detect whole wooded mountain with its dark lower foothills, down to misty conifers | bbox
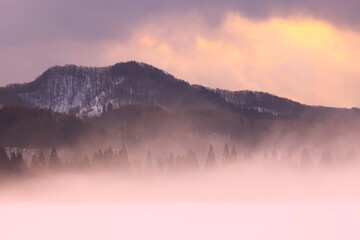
[0,61,360,148]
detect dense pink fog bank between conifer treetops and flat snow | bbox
[0,159,360,203]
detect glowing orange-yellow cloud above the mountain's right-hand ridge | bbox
[104,14,360,107]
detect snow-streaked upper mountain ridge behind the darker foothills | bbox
[0,61,357,119]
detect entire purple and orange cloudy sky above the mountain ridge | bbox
[0,0,360,107]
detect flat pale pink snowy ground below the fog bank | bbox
[0,203,360,240]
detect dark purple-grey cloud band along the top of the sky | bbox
[0,0,360,45]
